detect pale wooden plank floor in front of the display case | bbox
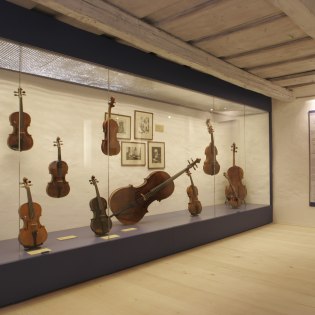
[0,224,315,315]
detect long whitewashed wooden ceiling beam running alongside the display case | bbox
[29,0,294,101]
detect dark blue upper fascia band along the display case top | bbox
[0,1,271,112]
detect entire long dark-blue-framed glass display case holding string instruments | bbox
[0,2,272,306]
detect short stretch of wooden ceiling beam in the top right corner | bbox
[268,0,315,39]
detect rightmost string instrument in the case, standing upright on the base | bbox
[223,143,247,209]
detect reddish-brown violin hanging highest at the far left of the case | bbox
[7,87,33,151]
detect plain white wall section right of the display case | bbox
[272,98,315,227]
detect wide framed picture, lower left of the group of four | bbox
[121,141,146,166]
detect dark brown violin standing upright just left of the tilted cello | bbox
[89,176,112,236]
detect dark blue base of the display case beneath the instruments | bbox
[0,205,272,306]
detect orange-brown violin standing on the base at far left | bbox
[18,177,47,249]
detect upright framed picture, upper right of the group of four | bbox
[134,110,153,140]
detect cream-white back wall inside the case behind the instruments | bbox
[0,70,270,239]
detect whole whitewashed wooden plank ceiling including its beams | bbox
[8,0,315,101]
